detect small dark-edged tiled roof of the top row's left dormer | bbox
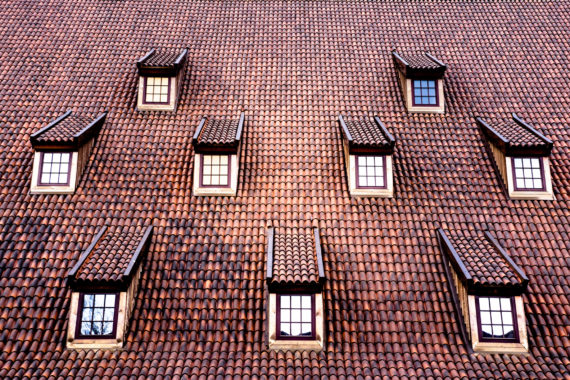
[137,49,188,77]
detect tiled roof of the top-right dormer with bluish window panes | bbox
[392,50,447,79]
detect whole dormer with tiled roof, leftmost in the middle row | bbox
[30,111,107,194]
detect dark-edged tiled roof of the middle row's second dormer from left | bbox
[192,112,245,153]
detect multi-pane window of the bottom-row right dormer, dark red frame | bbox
[477,297,519,342]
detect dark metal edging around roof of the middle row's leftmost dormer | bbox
[30,111,107,150]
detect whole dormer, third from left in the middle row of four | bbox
[339,116,396,197]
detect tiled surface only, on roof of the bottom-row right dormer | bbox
[449,234,522,286]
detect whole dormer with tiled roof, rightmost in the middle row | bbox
[476,114,554,200]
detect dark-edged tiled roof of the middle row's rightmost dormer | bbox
[476,113,553,156]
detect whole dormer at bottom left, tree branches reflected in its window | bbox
[67,226,152,348]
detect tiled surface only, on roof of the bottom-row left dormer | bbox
[75,226,145,282]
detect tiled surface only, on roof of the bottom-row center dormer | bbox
[272,228,319,284]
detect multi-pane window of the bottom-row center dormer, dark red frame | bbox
[277,294,315,339]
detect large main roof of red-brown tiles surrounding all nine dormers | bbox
[0,0,570,379]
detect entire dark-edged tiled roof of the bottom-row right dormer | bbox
[438,229,528,294]
